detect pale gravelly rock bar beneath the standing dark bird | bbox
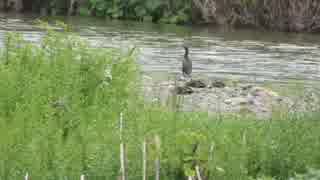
[143,76,320,119]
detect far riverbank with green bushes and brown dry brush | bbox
[0,0,320,32]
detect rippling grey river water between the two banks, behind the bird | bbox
[0,14,320,84]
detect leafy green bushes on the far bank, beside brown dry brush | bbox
[90,0,192,23]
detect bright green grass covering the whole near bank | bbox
[0,25,320,180]
